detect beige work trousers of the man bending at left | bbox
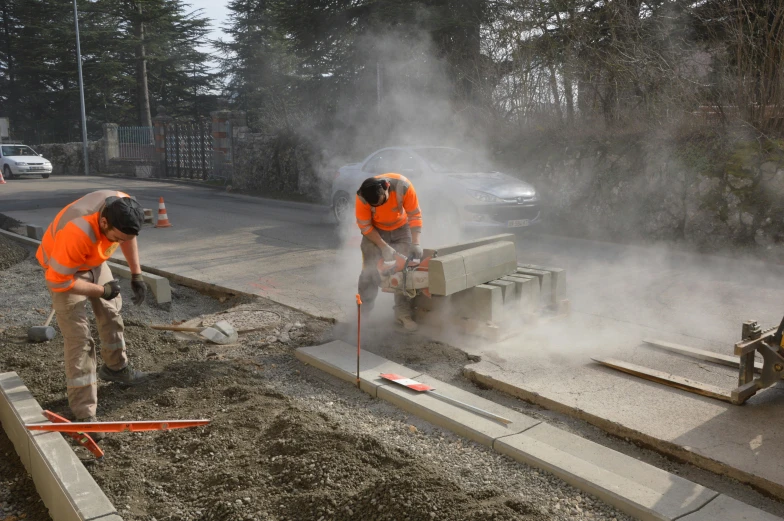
[50,263,128,420]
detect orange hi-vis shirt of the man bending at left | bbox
[35,190,129,293]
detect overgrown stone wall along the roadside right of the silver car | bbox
[508,137,784,251]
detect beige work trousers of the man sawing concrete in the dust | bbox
[357,224,414,318]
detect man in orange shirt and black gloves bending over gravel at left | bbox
[36,190,147,421]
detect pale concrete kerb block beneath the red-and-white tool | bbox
[378,375,541,447]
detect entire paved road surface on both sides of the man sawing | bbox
[0,177,784,504]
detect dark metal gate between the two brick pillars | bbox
[164,121,215,179]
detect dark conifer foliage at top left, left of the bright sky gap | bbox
[0,0,216,143]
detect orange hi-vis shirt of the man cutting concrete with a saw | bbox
[354,174,422,235]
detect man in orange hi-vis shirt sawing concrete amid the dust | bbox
[355,173,422,331]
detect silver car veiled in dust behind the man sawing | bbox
[330,146,541,228]
